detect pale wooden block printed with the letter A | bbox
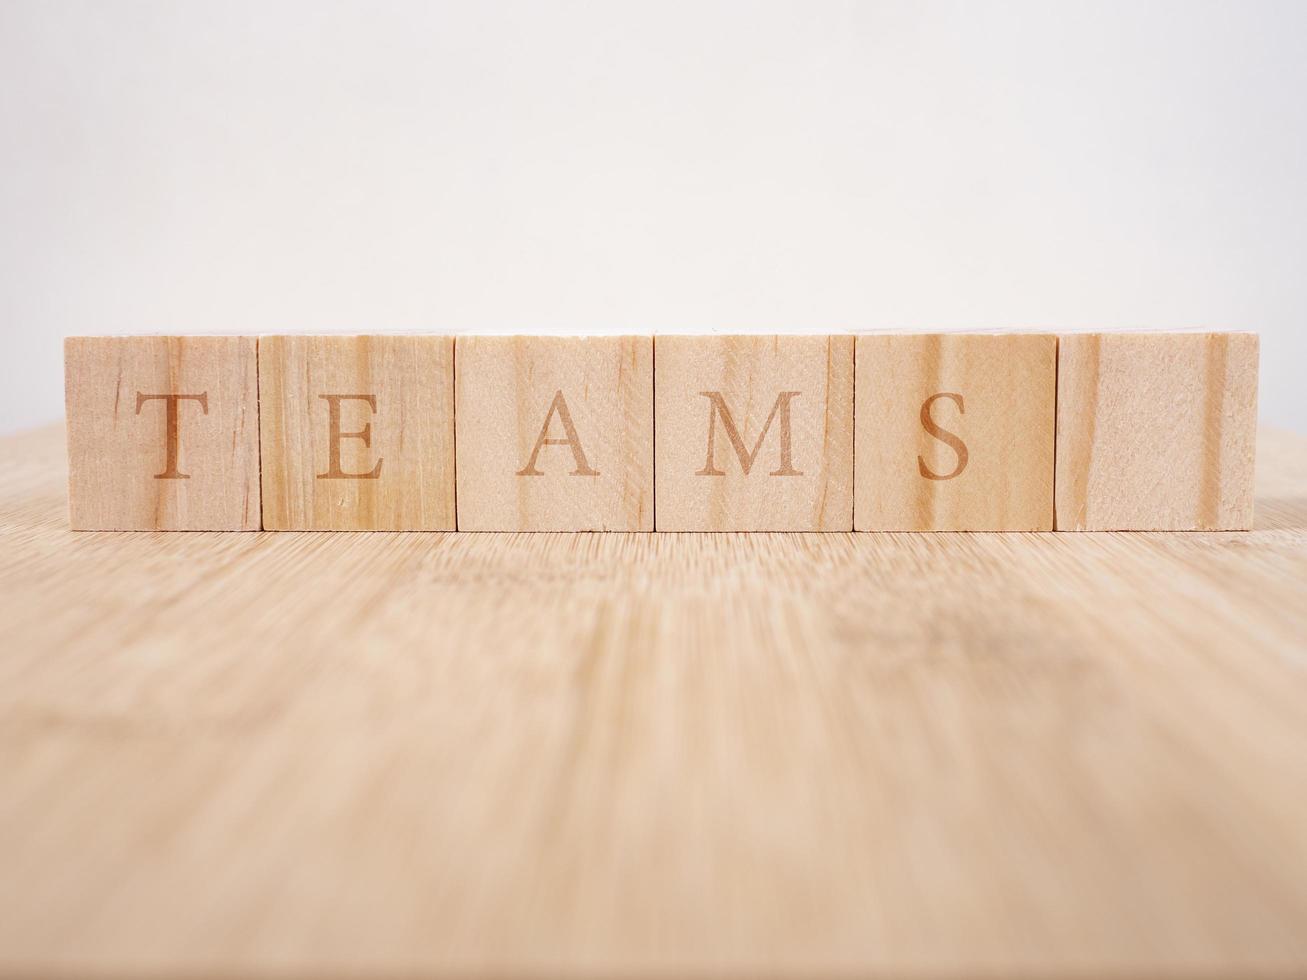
[455,337,654,531]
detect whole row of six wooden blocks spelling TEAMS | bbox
[65,333,1257,531]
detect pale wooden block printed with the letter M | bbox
[654,336,853,531]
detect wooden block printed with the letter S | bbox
[853,333,1057,531]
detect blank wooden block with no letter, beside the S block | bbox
[1056,333,1257,531]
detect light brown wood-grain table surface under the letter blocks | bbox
[0,429,1307,977]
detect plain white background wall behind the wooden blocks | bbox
[0,0,1307,431]
